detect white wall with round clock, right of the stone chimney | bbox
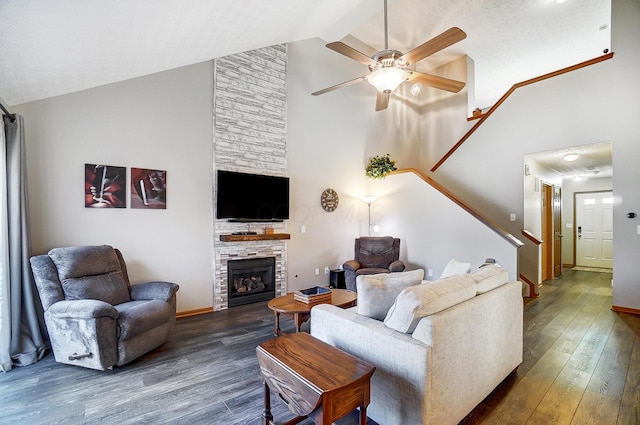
[287,39,417,291]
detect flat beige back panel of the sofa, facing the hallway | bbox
[413,281,523,423]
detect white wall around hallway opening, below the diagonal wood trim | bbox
[433,0,640,309]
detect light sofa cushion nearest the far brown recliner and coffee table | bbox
[356,269,424,320]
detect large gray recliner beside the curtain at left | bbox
[30,245,179,370]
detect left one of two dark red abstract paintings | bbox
[84,164,127,208]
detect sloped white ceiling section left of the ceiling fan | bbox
[0,0,375,105]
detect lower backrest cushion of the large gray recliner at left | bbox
[61,271,131,305]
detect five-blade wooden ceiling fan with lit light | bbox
[311,0,467,111]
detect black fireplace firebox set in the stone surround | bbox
[227,257,276,307]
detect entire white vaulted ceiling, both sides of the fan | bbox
[0,0,611,108]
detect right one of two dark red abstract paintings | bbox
[131,167,167,209]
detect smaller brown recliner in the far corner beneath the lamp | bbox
[342,236,405,291]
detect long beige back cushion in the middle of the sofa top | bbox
[384,275,476,333]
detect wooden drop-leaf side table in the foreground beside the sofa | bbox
[256,332,376,425]
